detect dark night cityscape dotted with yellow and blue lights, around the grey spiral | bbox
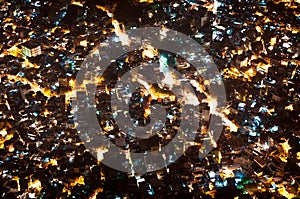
[0,0,300,199]
